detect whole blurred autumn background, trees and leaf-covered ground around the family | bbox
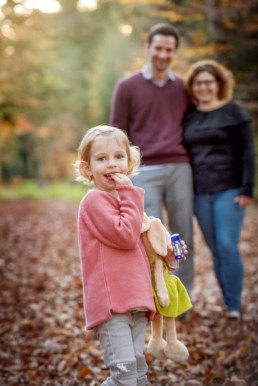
[0,0,258,386]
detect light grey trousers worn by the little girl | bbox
[95,311,148,386]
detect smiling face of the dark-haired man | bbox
[146,35,177,72]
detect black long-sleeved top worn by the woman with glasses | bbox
[184,102,254,196]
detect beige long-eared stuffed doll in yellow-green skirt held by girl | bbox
[142,214,192,362]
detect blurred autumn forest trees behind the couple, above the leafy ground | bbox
[0,0,258,199]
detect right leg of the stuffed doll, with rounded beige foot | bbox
[164,317,189,362]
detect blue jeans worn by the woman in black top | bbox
[194,189,245,311]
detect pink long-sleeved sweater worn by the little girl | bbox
[78,186,156,329]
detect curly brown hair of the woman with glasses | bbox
[184,59,235,103]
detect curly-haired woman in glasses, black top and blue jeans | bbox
[185,60,254,320]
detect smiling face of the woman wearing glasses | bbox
[192,71,219,104]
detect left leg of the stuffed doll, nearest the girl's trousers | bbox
[148,312,166,359]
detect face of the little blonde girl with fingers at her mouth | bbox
[89,135,129,195]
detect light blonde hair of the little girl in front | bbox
[74,125,141,184]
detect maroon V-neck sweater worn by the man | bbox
[110,73,189,165]
